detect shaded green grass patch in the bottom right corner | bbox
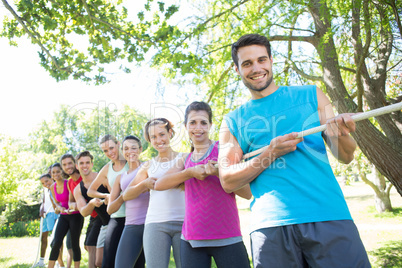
[369,241,402,268]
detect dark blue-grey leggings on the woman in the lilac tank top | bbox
[115,224,144,267]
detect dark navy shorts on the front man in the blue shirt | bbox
[251,220,371,268]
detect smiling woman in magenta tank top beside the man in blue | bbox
[155,102,251,268]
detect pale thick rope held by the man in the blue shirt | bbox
[243,102,402,160]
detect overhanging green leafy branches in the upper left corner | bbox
[1,0,159,84]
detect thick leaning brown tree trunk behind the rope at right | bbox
[308,0,402,196]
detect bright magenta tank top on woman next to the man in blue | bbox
[182,142,241,240]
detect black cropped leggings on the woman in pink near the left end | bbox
[49,213,84,262]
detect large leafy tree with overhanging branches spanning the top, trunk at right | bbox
[2,0,402,195]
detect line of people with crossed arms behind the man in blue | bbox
[37,102,251,268]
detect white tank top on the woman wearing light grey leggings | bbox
[145,153,185,224]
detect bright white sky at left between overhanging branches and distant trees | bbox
[0,2,195,138]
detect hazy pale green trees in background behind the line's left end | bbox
[0,104,156,217]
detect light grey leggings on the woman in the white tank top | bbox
[144,221,183,268]
